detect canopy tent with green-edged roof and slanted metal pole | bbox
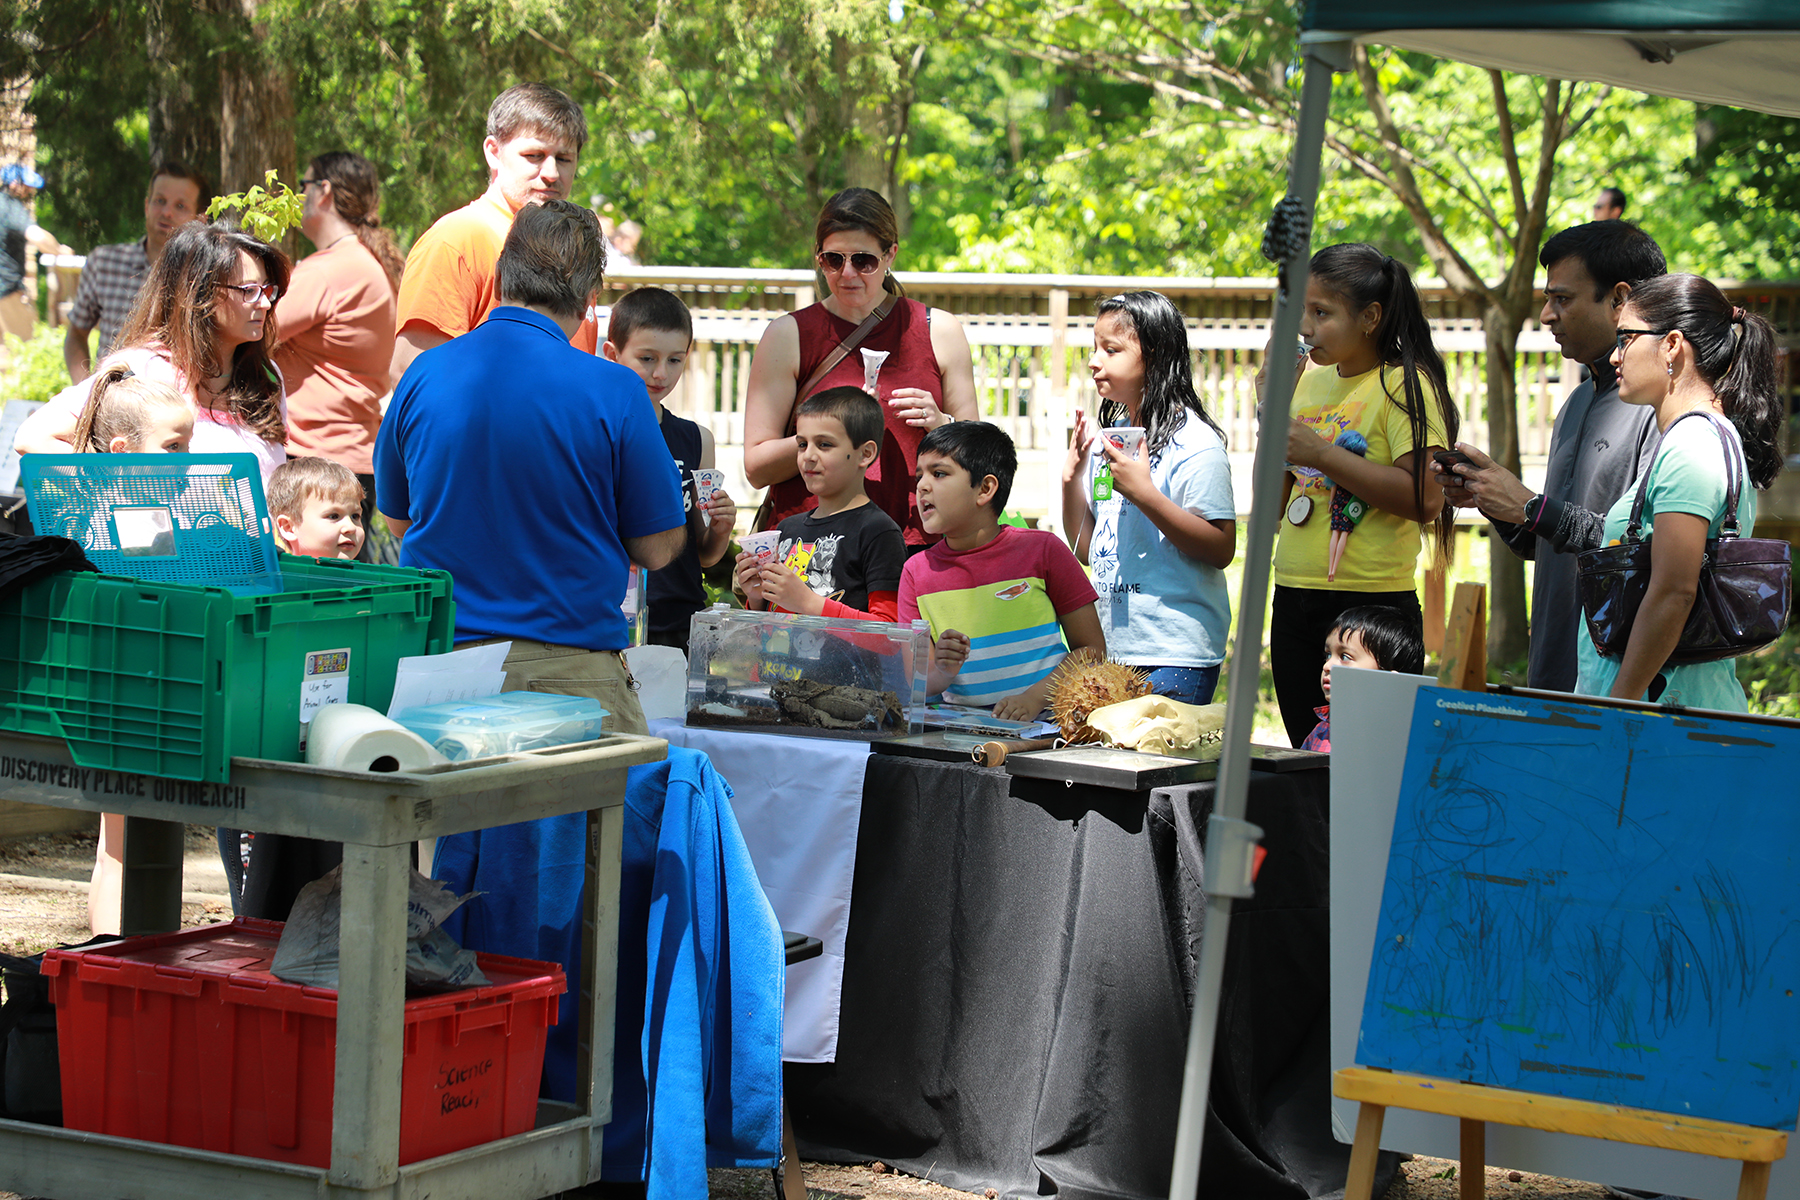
[1168,0,1800,1200]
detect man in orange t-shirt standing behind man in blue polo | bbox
[389,83,596,383]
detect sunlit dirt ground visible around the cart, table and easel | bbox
[0,826,1606,1200]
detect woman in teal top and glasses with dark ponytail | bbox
[1575,275,1782,712]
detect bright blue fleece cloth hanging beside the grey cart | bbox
[432,747,785,1200]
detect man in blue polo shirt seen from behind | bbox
[374,200,688,732]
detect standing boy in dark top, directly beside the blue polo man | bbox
[599,288,738,651]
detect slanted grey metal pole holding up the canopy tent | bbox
[1168,38,1350,1200]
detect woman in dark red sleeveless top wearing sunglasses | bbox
[743,187,979,545]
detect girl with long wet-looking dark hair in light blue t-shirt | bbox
[1062,291,1237,703]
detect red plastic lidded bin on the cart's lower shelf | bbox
[43,918,565,1168]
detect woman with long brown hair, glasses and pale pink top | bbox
[14,221,288,482]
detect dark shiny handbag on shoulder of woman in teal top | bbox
[1575,412,1793,666]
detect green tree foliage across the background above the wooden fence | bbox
[10,0,1800,281]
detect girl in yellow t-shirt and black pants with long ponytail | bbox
[1269,245,1458,745]
